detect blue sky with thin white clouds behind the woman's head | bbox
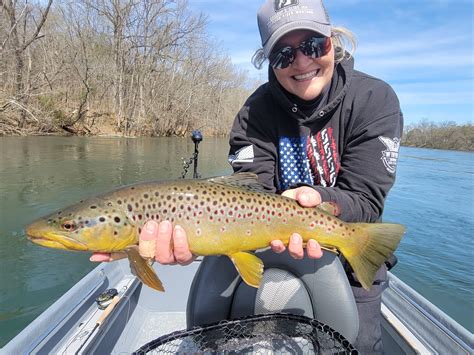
[189,0,474,124]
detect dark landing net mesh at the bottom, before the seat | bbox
[135,314,358,355]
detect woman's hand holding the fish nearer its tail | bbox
[270,186,323,259]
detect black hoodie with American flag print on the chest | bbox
[229,59,403,222]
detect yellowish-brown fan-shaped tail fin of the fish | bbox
[340,223,405,290]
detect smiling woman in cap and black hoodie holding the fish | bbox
[93,0,403,354]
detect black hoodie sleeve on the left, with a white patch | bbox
[229,90,277,192]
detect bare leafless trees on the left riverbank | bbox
[0,0,254,136]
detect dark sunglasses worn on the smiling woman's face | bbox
[268,37,330,69]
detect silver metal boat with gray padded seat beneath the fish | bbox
[0,135,474,354]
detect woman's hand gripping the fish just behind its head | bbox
[90,221,196,265]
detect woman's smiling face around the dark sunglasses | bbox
[273,30,334,101]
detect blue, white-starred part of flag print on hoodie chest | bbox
[279,137,313,191]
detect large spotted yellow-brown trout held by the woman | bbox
[26,173,405,291]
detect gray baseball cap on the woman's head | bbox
[257,0,331,58]
